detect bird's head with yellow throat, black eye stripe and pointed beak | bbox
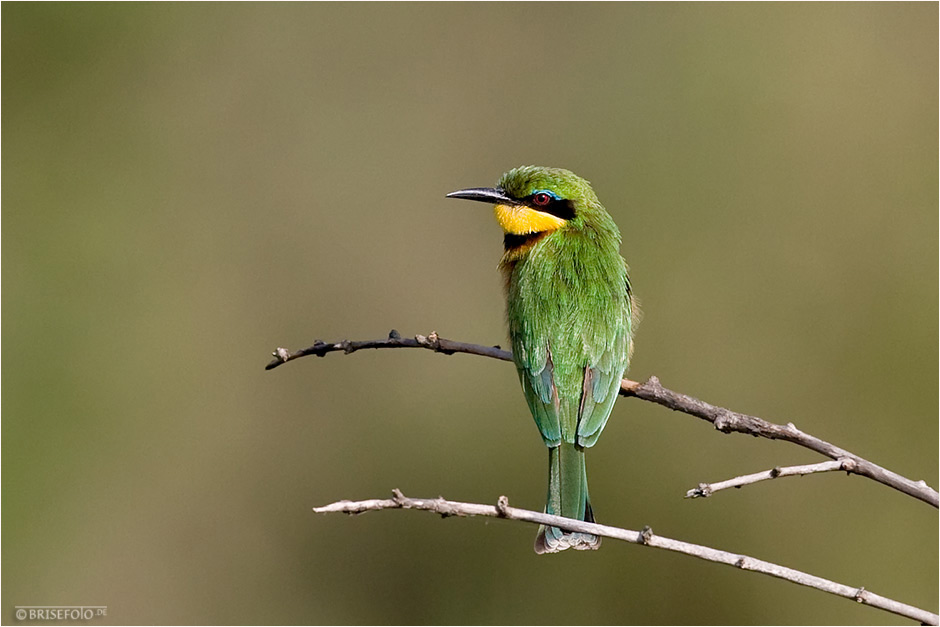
[447,166,606,235]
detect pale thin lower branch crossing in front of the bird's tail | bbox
[313,489,940,625]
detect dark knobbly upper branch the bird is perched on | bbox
[265,330,940,507]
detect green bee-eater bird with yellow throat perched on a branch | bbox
[447,166,636,553]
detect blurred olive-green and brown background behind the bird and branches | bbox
[2,3,938,624]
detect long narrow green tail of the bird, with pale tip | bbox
[535,442,601,553]
